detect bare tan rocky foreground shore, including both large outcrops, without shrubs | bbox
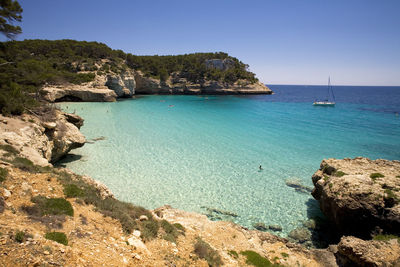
[0,110,400,266]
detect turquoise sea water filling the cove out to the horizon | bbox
[58,86,400,236]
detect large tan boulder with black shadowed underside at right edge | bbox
[312,157,400,238]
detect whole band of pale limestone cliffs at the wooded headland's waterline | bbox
[42,70,273,102]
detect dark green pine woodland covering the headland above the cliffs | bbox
[0,40,257,115]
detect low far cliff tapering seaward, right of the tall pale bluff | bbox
[135,71,272,95]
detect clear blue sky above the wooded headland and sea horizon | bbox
[2,0,400,85]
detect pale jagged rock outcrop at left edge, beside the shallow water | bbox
[0,110,86,166]
